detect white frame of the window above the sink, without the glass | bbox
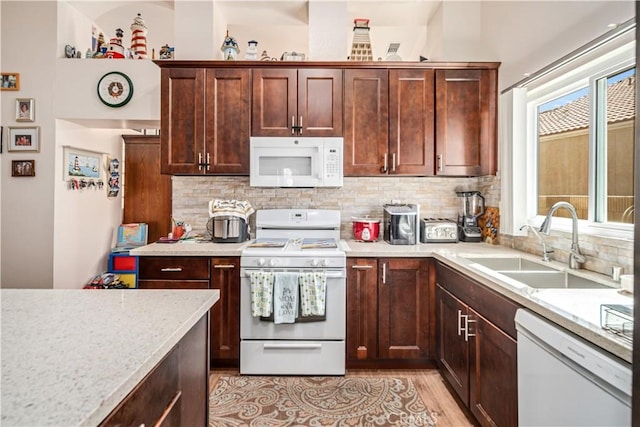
[507,41,637,239]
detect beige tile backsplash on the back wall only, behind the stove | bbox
[173,176,500,239]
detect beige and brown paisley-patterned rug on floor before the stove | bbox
[209,376,435,427]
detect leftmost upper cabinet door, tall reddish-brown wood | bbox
[160,68,204,174]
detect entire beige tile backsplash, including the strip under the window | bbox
[172,176,633,274]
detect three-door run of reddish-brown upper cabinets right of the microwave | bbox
[344,64,497,176]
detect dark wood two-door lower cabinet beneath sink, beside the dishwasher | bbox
[435,263,519,426]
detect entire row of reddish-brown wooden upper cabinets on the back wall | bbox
[156,61,499,176]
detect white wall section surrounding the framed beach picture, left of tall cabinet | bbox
[53,120,123,288]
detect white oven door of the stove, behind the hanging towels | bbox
[240,268,347,340]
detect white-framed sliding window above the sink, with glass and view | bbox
[527,42,636,234]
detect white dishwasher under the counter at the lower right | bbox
[515,309,631,427]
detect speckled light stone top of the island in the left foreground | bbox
[0,289,219,427]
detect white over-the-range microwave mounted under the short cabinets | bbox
[249,136,344,187]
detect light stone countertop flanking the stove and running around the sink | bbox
[131,239,633,363]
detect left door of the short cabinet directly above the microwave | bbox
[251,68,298,136]
